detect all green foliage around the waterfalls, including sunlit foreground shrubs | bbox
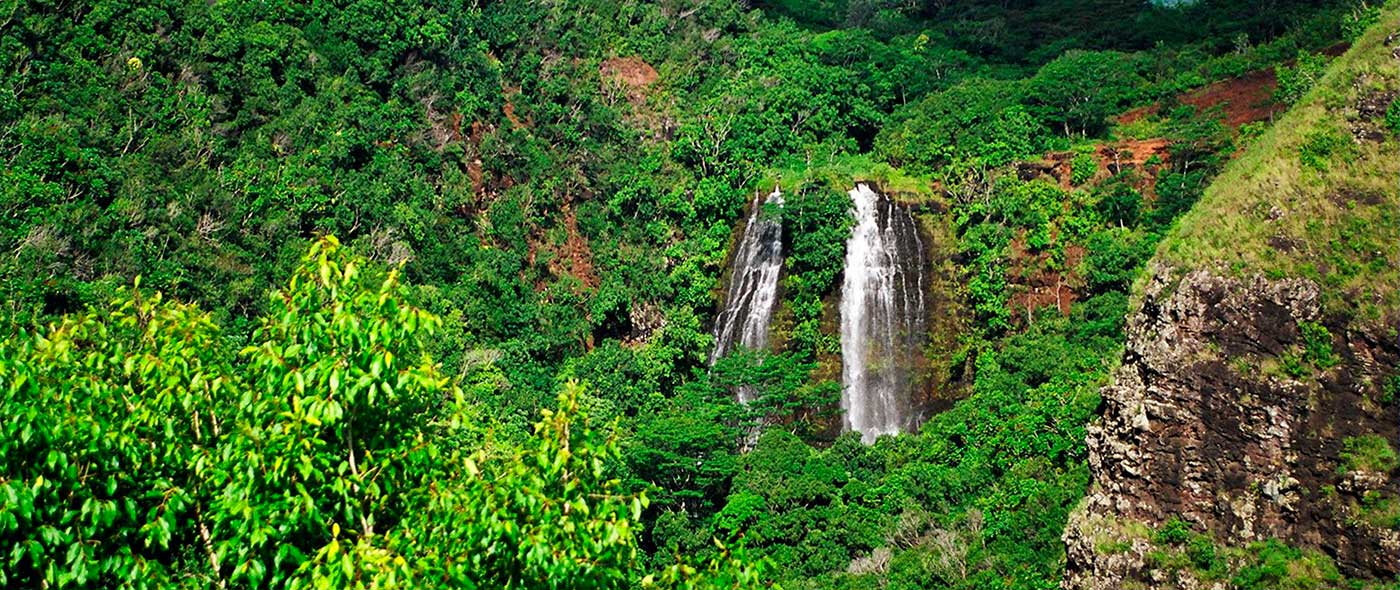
[0,0,1377,589]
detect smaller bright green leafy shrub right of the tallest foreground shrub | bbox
[393,384,647,589]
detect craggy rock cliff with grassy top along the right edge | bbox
[1063,11,1400,590]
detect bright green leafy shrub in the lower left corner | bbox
[0,291,228,587]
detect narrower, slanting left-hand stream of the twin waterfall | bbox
[710,188,783,404]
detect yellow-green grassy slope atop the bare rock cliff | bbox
[1140,1,1400,322]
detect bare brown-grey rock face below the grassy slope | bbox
[1064,266,1400,589]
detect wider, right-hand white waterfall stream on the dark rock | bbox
[841,184,927,443]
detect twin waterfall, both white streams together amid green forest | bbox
[710,184,928,443]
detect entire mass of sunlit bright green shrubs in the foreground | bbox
[0,237,757,589]
